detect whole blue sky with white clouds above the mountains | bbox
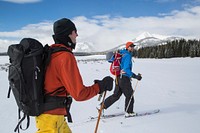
[0,0,200,50]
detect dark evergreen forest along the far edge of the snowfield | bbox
[137,39,200,58]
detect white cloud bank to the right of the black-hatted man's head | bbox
[74,6,200,49]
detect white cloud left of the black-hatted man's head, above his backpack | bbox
[0,21,53,52]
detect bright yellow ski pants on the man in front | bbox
[35,114,72,133]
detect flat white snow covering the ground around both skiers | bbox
[0,56,200,133]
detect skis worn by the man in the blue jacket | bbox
[90,109,160,121]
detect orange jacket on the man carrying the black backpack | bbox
[44,44,99,115]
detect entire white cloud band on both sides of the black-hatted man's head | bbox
[0,6,200,51]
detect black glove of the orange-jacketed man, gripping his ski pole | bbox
[94,76,113,94]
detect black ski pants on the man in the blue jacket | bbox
[104,76,134,113]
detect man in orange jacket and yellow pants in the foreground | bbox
[36,18,113,133]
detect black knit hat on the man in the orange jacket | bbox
[53,18,76,36]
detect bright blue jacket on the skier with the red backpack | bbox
[120,49,135,78]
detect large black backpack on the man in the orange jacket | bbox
[7,38,72,132]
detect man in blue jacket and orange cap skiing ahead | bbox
[103,42,142,117]
